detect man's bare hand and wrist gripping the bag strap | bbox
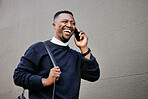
[42,67,61,87]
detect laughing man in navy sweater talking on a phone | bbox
[13,11,100,99]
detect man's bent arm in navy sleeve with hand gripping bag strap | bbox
[13,43,61,90]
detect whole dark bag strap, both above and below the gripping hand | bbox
[43,42,57,99]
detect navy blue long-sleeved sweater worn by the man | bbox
[13,40,100,99]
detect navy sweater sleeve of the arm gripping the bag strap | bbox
[13,46,43,90]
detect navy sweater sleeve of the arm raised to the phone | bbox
[81,54,100,82]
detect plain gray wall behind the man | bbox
[0,0,148,99]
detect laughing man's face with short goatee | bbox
[53,13,75,43]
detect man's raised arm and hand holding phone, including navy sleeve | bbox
[74,31,100,81]
